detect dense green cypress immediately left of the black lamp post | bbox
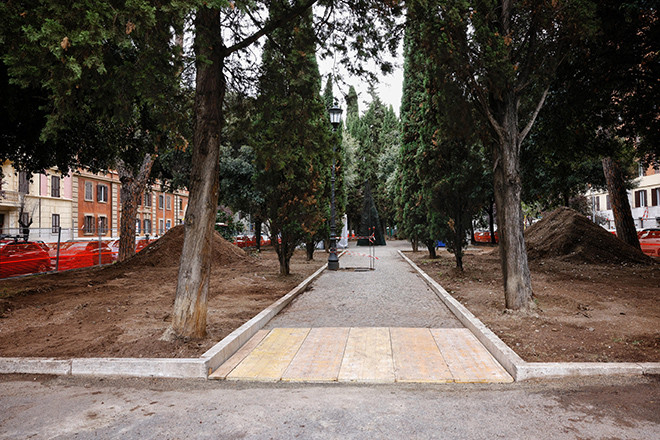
[255,2,332,275]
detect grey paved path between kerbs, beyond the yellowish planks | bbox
[266,241,463,329]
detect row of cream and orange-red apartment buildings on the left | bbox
[0,162,188,242]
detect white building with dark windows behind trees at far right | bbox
[587,163,660,229]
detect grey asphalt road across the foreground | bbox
[0,375,660,440]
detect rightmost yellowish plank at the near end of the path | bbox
[431,328,513,382]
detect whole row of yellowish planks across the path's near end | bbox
[209,327,513,383]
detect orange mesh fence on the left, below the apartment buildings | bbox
[0,227,158,278]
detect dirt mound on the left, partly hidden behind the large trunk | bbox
[123,225,250,268]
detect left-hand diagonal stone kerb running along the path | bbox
[201,255,328,377]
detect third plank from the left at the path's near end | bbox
[282,327,349,382]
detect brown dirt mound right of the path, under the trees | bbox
[525,207,654,264]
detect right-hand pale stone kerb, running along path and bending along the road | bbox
[398,251,660,381]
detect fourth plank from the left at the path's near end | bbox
[338,327,394,383]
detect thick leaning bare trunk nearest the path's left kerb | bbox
[172,7,226,338]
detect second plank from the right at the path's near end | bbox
[390,328,453,383]
